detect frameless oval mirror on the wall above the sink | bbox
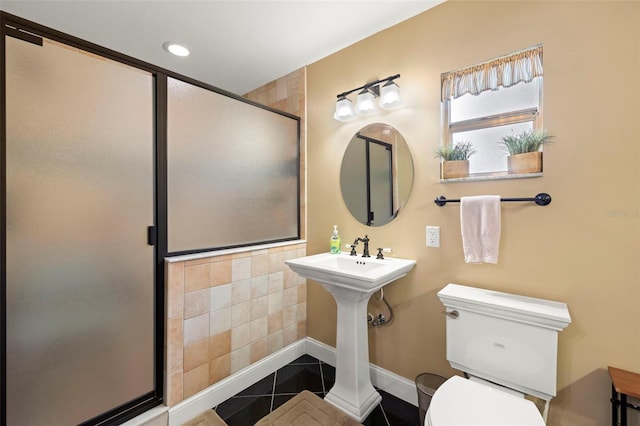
[340,123,413,226]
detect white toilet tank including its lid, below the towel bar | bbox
[438,284,571,400]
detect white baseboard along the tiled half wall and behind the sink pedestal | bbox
[169,337,418,426]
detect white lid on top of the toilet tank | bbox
[438,283,571,331]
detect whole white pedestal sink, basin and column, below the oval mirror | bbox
[285,252,416,422]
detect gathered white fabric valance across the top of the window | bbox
[441,46,542,101]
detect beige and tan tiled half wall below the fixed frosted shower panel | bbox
[165,241,307,407]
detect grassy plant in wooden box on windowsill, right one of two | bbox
[501,129,553,174]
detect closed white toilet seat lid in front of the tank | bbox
[425,376,545,426]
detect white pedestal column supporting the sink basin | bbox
[321,283,382,422]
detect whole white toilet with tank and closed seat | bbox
[425,284,571,426]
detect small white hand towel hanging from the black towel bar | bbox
[460,195,500,263]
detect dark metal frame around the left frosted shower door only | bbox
[0,11,166,425]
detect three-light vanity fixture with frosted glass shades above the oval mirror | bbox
[333,74,402,121]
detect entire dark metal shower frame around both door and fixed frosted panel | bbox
[0,10,301,425]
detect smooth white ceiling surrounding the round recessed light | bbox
[0,0,444,94]
